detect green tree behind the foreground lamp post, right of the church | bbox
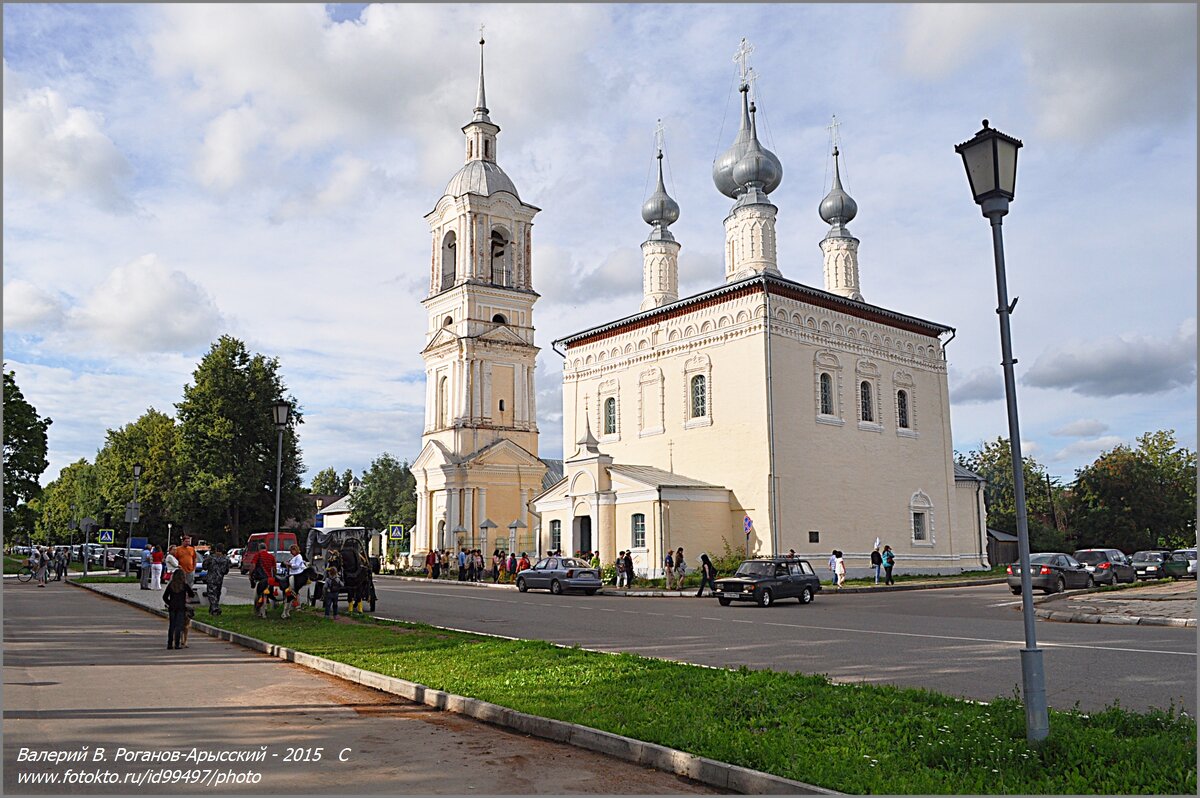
[955,437,1070,552]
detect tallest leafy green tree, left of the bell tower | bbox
[175,336,311,545]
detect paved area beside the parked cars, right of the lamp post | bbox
[1034,580,1196,626]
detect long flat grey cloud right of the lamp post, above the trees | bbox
[1024,319,1196,396]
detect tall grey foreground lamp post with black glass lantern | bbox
[954,119,1050,744]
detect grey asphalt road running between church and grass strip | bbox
[350,578,1196,713]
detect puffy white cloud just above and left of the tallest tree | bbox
[73,253,222,352]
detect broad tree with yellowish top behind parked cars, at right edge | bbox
[1072,430,1196,552]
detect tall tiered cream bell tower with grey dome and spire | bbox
[413,36,545,552]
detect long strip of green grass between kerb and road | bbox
[196,606,1196,794]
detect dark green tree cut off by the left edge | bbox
[4,371,52,538]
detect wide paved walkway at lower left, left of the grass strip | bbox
[4,583,715,794]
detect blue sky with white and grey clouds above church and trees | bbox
[4,4,1196,485]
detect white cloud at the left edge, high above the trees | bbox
[4,61,136,214]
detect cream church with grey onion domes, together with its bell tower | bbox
[413,39,988,576]
